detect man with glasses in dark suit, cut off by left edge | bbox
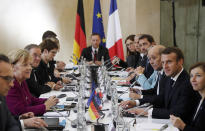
[0,54,47,131]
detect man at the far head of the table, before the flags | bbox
[81,33,111,66]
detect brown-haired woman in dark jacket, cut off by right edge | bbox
[170,62,205,131]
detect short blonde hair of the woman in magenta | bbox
[8,49,31,65]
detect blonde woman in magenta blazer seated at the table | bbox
[6,49,58,116]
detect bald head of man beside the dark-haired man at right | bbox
[148,45,165,71]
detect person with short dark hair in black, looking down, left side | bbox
[36,39,71,89]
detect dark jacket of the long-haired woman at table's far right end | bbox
[118,52,140,68]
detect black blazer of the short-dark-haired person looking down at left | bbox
[36,60,62,85]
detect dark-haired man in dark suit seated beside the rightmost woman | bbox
[120,47,197,123]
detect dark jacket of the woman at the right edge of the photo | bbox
[183,97,205,131]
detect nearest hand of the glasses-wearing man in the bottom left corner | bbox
[23,117,48,128]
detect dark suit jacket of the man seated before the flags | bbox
[81,46,111,66]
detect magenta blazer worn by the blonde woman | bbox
[6,80,46,116]
